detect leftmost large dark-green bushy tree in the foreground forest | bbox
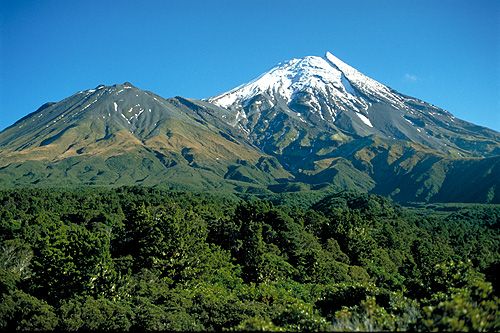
[30,219,113,303]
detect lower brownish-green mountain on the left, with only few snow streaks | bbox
[0,83,291,191]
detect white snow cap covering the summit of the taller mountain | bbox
[206,52,404,118]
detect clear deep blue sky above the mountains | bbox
[0,0,500,131]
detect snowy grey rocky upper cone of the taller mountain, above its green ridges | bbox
[207,53,500,161]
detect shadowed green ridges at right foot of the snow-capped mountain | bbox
[296,135,500,203]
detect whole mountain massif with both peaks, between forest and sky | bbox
[0,53,500,203]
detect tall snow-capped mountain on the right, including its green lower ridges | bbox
[206,53,500,202]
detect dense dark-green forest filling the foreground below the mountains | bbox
[0,187,500,331]
